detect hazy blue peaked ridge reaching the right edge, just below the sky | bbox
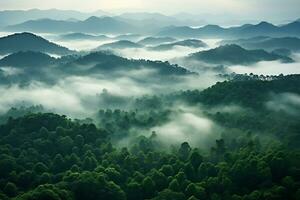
[157,21,300,38]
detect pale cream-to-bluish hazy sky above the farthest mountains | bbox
[0,0,300,21]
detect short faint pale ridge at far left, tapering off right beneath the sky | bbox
[0,9,110,26]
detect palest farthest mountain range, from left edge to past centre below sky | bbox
[0,9,203,31]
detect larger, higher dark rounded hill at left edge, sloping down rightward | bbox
[0,33,73,55]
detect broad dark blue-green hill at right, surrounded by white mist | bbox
[187,45,293,65]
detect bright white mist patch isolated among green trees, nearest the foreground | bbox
[151,105,221,148]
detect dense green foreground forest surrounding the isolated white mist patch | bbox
[0,75,300,200]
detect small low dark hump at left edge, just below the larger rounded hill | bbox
[0,51,56,68]
